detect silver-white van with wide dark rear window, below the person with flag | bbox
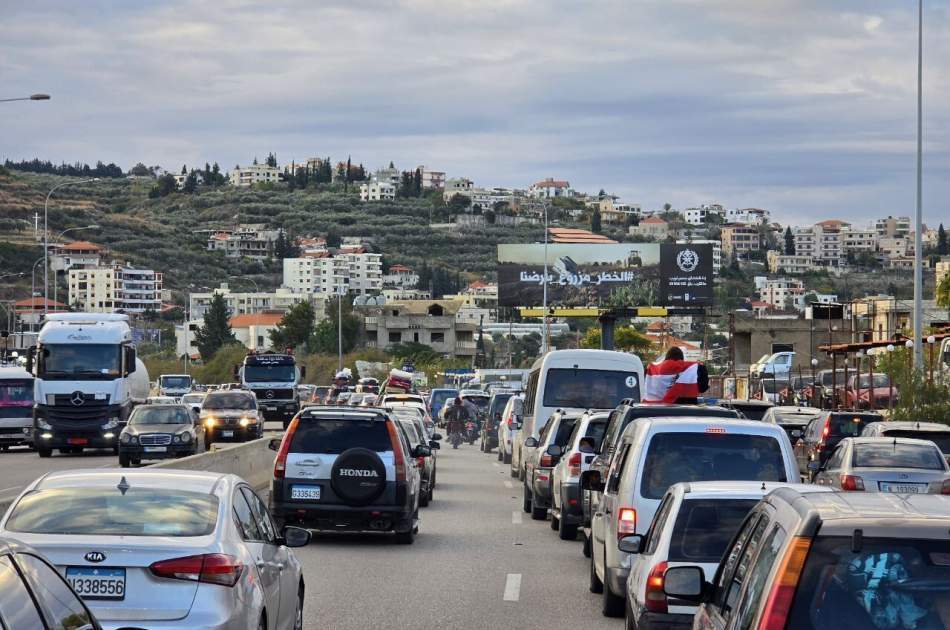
[586,417,799,616]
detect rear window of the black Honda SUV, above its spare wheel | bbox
[290,420,393,455]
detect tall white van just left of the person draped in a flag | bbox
[511,350,643,480]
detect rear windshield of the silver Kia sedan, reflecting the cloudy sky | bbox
[6,488,218,537]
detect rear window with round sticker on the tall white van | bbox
[544,368,640,409]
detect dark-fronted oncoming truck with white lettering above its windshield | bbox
[234,353,306,429]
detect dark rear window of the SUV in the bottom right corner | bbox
[787,536,950,630]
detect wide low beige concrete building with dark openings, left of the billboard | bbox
[361,300,478,359]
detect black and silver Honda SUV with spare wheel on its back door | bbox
[270,407,432,544]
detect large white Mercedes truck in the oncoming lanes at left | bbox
[27,313,149,457]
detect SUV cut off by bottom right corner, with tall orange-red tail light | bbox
[661,487,950,630]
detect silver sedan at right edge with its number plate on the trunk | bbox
[809,437,950,494]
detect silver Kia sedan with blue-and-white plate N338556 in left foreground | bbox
[0,469,310,630]
